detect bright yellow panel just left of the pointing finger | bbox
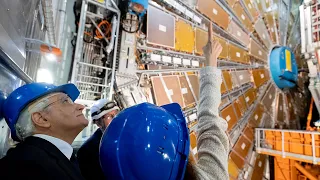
[176,19,194,53]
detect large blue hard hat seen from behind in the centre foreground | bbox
[100,103,190,180]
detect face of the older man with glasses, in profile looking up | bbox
[45,93,88,132]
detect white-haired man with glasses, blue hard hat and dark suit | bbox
[0,83,88,180]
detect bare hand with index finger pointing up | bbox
[203,22,222,67]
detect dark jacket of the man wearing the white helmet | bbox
[77,129,106,180]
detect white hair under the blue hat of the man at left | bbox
[15,93,57,141]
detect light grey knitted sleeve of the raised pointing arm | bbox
[195,67,229,180]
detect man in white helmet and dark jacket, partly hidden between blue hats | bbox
[77,99,120,180]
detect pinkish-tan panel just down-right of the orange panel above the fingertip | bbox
[228,20,250,47]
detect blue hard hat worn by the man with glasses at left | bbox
[1,83,80,141]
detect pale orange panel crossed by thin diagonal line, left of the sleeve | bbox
[151,76,185,107]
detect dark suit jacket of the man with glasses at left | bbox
[0,136,84,180]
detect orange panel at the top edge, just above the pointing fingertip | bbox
[197,0,229,29]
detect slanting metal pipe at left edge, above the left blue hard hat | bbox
[0,47,33,83]
